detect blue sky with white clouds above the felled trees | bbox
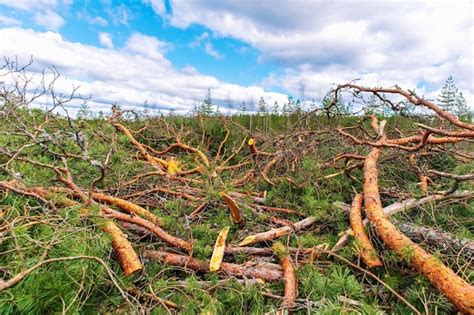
[0,0,474,114]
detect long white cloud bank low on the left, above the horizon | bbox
[0,28,286,114]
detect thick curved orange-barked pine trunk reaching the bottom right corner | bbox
[364,147,474,314]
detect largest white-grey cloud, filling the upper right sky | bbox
[151,0,474,106]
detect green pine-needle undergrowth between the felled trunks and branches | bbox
[0,109,474,314]
